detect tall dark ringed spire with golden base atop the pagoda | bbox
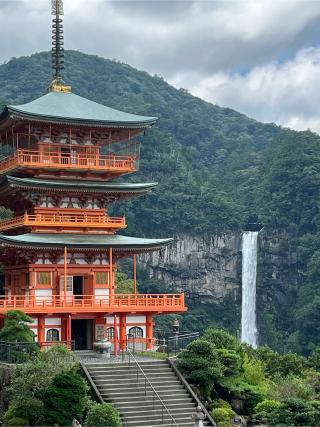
[49,0,71,92]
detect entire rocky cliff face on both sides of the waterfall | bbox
[140,231,302,349]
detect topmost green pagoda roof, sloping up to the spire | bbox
[3,92,157,128]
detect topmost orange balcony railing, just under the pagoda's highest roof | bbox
[0,149,136,173]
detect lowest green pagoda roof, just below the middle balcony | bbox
[0,233,173,252]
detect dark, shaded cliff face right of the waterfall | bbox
[257,231,303,350]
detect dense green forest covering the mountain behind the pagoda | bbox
[0,51,320,354]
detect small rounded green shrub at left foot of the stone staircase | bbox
[85,403,122,427]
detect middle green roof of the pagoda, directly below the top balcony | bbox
[0,175,157,195]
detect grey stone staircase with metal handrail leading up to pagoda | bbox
[85,360,212,427]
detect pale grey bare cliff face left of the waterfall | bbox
[140,234,241,303]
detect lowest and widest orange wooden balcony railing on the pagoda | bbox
[0,293,186,314]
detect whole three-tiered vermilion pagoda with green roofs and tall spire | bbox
[0,0,186,349]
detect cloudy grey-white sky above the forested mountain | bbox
[0,0,320,133]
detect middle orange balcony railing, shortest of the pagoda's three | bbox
[0,214,127,231]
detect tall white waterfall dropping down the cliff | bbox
[241,231,259,347]
